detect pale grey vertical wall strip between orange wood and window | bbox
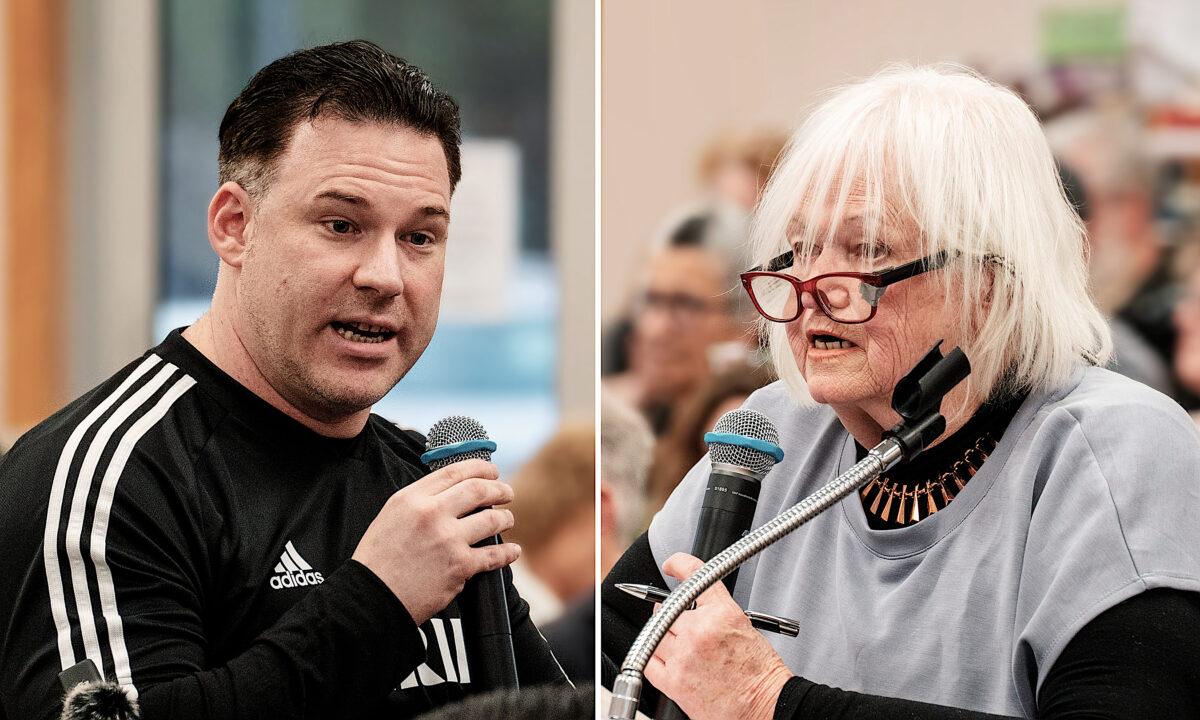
[64,0,157,397]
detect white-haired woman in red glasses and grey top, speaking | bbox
[602,66,1200,719]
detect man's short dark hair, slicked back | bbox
[217,40,462,194]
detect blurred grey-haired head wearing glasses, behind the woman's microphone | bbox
[605,205,755,433]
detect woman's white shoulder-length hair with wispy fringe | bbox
[751,64,1112,402]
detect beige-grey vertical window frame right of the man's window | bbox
[550,0,596,420]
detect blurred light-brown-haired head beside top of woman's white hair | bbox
[696,130,787,212]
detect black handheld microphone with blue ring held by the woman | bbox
[654,409,784,720]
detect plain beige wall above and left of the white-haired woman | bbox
[601,0,1123,322]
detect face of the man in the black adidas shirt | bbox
[236,118,450,419]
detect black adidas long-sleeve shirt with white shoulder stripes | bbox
[0,331,564,720]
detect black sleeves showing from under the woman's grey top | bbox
[609,534,1200,720]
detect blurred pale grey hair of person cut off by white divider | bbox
[600,390,654,545]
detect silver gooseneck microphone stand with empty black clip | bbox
[608,341,971,720]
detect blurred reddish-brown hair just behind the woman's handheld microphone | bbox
[648,364,775,510]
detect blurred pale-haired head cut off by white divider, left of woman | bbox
[600,391,658,577]
